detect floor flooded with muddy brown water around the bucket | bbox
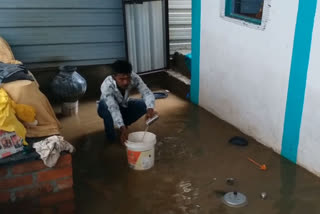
[57,95,320,214]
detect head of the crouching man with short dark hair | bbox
[111,60,132,90]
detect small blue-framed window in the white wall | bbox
[225,0,264,25]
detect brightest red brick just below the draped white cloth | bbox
[38,167,72,182]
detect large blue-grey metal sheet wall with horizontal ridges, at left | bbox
[0,0,125,67]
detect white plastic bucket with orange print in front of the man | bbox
[125,132,157,170]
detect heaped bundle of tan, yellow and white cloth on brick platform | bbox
[0,37,74,167]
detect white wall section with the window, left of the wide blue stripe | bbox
[199,0,300,153]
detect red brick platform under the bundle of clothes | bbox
[0,153,74,213]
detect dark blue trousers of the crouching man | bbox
[98,99,147,141]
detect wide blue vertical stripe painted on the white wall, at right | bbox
[281,0,317,162]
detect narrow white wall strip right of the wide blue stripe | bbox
[298,3,320,176]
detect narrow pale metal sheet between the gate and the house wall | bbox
[169,0,191,54]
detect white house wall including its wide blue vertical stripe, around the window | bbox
[199,0,320,176]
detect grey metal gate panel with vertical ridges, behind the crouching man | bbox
[126,0,166,73]
